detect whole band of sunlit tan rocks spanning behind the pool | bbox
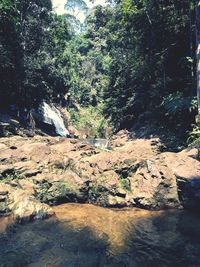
[0,132,200,220]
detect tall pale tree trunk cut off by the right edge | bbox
[196,1,200,121]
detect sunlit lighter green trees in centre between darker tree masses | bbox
[67,7,111,106]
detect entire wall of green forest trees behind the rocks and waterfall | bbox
[0,0,198,146]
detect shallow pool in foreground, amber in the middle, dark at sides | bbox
[0,204,200,267]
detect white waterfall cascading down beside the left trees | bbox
[42,102,69,137]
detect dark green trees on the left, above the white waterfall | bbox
[0,0,69,107]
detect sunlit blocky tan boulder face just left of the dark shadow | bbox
[131,159,180,209]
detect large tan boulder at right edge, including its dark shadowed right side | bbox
[128,149,200,211]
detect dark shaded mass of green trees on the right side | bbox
[101,0,196,135]
